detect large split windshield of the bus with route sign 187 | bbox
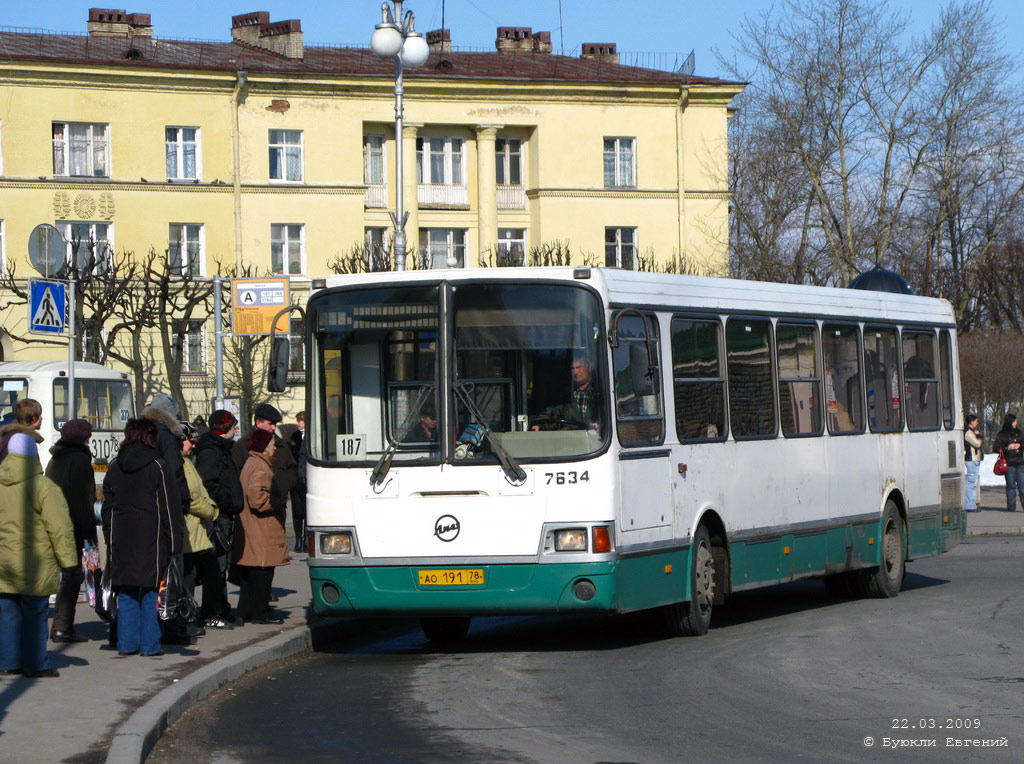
[309,283,608,466]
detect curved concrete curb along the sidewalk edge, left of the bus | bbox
[106,620,386,764]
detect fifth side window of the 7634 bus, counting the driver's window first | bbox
[821,324,864,435]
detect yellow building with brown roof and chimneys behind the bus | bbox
[0,9,742,413]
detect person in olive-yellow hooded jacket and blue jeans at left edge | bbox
[0,432,80,677]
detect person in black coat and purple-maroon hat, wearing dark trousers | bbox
[46,419,96,642]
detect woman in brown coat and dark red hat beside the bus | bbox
[236,430,289,624]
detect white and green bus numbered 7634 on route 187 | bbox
[270,267,966,639]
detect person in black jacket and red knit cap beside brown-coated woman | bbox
[195,409,245,621]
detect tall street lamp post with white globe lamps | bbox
[370,0,430,270]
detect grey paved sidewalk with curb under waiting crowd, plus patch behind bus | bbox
[0,497,1024,764]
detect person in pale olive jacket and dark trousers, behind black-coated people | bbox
[178,422,232,629]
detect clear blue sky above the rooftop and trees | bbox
[9,0,1024,76]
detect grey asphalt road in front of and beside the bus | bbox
[146,537,1024,764]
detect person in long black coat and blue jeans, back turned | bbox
[102,419,184,655]
